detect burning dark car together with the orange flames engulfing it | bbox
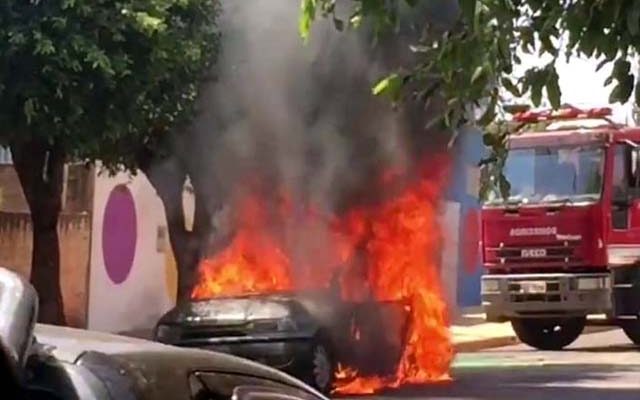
[155,159,453,394]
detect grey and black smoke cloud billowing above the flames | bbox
[176,0,456,276]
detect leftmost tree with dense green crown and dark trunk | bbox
[0,0,218,324]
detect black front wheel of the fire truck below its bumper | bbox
[511,317,587,350]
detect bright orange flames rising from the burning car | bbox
[193,157,453,394]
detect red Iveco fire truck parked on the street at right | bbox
[480,107,640,350]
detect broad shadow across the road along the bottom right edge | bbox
[348,365,640,400]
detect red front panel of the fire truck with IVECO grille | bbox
[482,204,606,274]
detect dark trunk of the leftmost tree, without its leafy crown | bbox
[11,140,66,325]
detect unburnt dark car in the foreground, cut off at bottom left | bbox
[0,268,326,400]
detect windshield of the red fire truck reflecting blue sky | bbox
[487,145,604,204]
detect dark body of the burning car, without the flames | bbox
[154,291,409,393]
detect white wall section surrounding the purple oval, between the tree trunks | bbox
[88,167,175,332]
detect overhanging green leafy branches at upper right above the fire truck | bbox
[300,0,640,195]
